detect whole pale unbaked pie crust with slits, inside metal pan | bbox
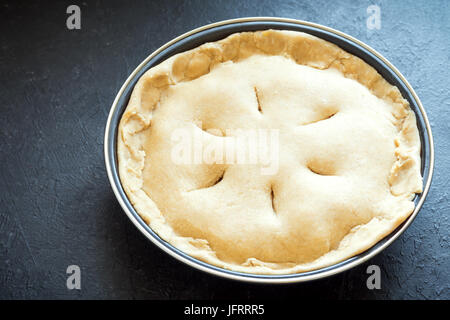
[117,30,422,274]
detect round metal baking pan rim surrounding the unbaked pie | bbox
[104,17,434,283]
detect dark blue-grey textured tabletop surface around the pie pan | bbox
[0,0,450,299]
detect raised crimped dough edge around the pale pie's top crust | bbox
[117,30,422,274]
